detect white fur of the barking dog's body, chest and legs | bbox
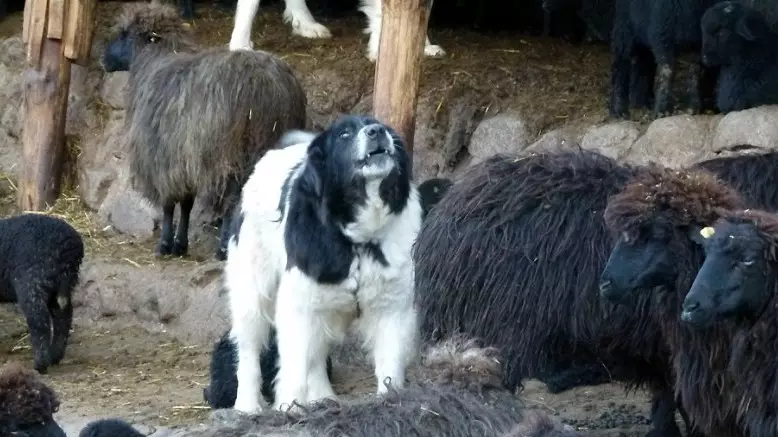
[225,136,421,413]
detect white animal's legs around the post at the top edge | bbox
[230,0,446,62]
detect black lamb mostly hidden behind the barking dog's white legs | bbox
[203,328,332,409]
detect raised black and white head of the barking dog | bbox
[300,115,410,197]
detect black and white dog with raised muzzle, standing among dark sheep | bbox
[225,116,422,412]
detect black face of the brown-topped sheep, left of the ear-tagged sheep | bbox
[600,221,679,304]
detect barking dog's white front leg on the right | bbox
[362,307,418,394]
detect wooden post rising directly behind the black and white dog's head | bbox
[373,0,432,179]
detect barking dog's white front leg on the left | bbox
[273,268,319,410]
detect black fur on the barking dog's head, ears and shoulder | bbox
[284,116,411,284]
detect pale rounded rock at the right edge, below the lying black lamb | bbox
[712,105,778,152]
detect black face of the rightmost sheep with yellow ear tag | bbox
[681,221,772,328]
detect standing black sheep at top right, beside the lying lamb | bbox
[609,0,718,117]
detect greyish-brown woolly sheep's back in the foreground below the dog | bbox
[190,337,579,437]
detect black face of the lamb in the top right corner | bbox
[700,1,767,66]
